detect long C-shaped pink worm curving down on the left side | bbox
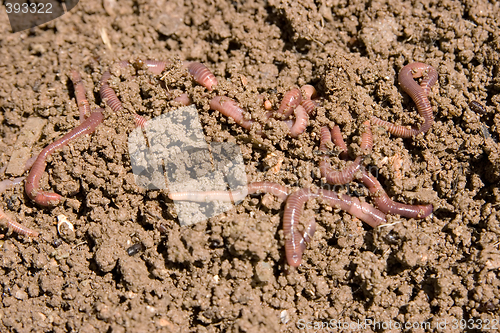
[25,109,103,206]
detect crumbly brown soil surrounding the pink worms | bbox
[0,0,500,332]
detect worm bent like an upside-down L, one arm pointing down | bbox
[283,189,386,267]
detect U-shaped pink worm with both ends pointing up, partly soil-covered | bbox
[319,121,373,185]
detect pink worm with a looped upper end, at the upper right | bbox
[371,62,438,138]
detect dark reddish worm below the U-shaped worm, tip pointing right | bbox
[361,170,434,219]
